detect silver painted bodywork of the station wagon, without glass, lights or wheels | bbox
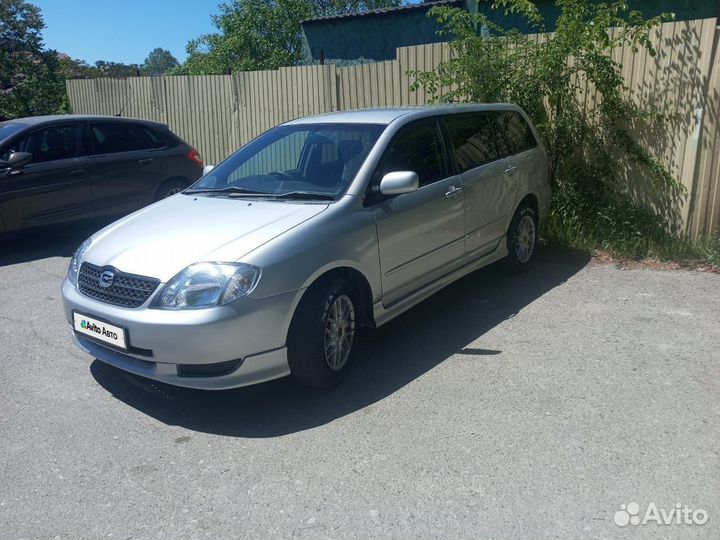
[62,105,550,389]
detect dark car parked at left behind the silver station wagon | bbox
[0,115,203,236]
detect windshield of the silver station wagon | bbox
[187,124,385,199]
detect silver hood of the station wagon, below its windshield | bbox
[83,194,328,282]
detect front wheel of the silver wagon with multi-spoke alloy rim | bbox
[287,278,358,388]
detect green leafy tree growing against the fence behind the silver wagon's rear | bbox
[412,0,685,256]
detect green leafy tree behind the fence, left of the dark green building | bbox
[176,0,401,75]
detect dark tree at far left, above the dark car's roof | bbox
[0,0,65,120]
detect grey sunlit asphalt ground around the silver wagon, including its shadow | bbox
[0,231,720,540]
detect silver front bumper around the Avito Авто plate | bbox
[62,279,298,389]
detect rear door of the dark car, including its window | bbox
[87,121,161,217]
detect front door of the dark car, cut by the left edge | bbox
[0,122,93,232]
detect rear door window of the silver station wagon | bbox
[445,113,508,172]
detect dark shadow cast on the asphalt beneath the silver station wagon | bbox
[90,248,590,438]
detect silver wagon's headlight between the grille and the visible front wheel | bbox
[150,263,260,309]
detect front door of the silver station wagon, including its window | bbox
[372,118,465,306]
